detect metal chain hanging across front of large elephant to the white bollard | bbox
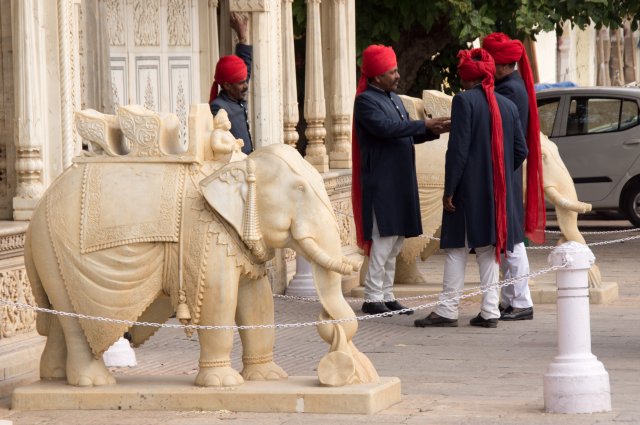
[0,261,568,330]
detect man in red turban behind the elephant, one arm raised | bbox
[209,13,253,155]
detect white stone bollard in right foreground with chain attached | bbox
[544,241,611,413]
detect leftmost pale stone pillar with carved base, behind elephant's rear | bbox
[11,0,46,220]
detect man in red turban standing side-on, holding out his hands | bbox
[352,45,449,314]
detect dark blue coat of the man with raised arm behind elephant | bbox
[209,43,253,155]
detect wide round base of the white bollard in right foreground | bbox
[544,356,611,413]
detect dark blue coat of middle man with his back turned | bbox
[440,85,527,250]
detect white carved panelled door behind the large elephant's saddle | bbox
[102,0,200,147]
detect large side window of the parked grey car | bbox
[566,97,638,136]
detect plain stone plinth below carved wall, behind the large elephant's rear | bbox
[0,331,46,397]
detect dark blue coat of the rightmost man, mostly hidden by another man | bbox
[495,72,529,243]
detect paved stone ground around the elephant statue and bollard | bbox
[0,215,640,425]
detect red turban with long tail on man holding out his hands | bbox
[351,44,398,255]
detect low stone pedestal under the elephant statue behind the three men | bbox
[351,282,618,305]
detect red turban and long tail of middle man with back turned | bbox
[458,49,507,262]
